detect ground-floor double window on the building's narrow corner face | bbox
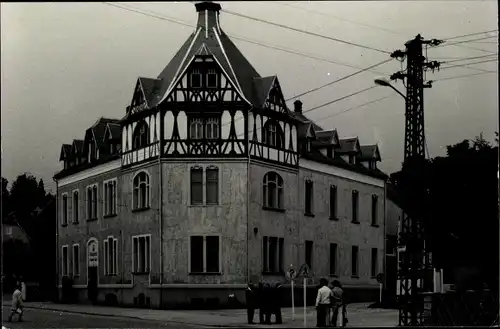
[189,235,221,273]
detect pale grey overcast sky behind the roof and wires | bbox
[1,0,499,191]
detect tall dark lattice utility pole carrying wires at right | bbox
[391,34,443,326]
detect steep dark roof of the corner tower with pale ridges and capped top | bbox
[148,2,260,108]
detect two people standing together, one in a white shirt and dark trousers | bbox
[316,278,347,327]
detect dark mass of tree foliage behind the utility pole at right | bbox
[391,134,499,284]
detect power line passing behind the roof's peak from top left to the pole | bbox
[104,2,387,75]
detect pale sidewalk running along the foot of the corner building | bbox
[3,300,398,328]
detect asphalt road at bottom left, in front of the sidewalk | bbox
[2,307,196,329]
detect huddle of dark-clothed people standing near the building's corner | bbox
[245,282,283,324]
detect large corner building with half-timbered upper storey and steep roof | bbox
[54,2,386,307]
